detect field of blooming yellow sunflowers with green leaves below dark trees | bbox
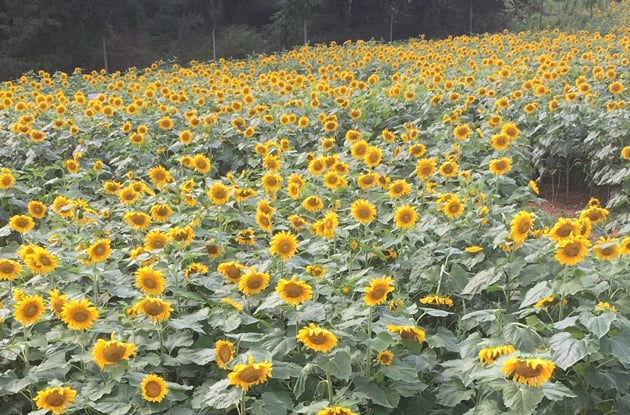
[0,2,630,415]
